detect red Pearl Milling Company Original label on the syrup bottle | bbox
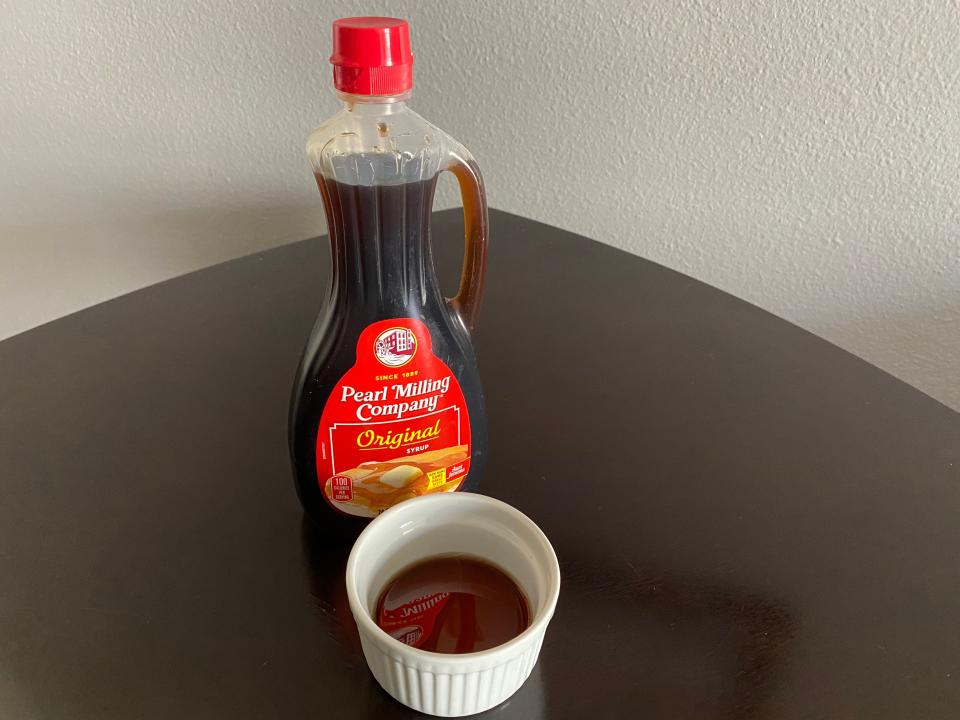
[317,318,470,517]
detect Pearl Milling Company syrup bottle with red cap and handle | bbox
[290,17,488,532]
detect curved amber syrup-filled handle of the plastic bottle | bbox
[446,153,490,332]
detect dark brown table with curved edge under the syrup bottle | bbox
[0,212,960,720]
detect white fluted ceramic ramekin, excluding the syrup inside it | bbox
[347,492,560,717]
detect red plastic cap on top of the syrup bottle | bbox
[330,17,413,95]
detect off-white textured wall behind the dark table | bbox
[0,0,960,408]
